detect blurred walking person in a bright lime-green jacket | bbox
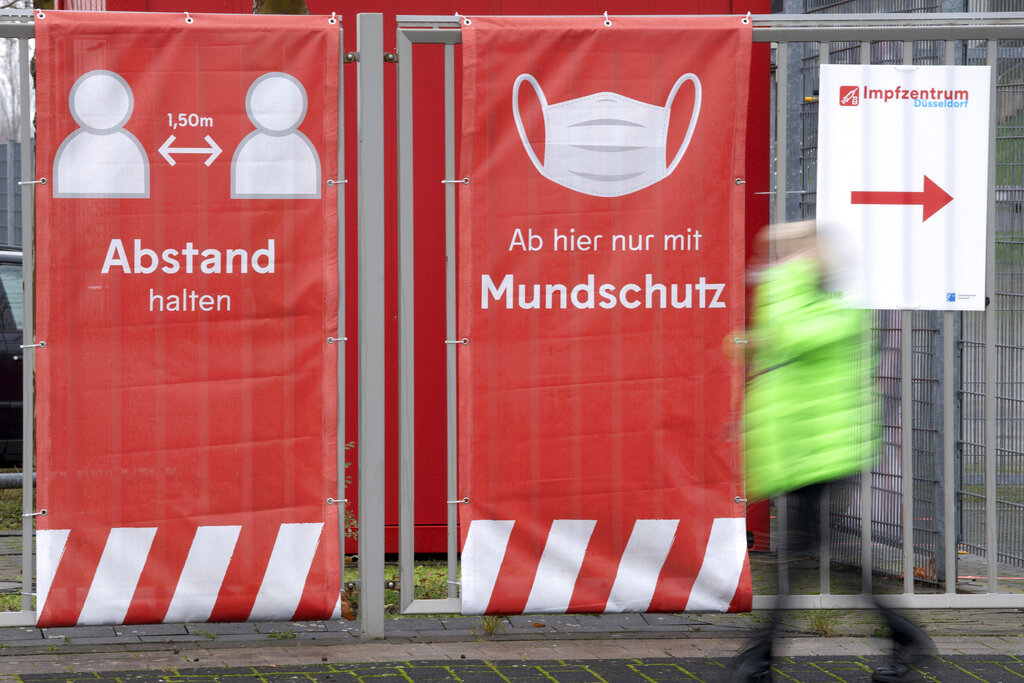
[729,221,932,682]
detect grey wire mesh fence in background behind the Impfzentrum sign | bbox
[774,7,1024,598]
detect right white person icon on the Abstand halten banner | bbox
[231,72,321,199]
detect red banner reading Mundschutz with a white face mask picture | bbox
[459,16,751,613]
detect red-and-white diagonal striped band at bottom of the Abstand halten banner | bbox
[36,522,340,626]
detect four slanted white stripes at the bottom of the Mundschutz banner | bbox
[462,517,746,614]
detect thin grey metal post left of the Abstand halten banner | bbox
[18,38,36,611]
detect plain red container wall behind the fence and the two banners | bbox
[106,0,771,553]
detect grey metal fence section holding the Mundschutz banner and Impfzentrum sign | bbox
[397,12,1024,613]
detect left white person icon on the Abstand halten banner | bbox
[53,69,150,198]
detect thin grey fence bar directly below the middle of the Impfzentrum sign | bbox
[899,40,913,593]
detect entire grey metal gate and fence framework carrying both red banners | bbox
[0,6,1024,638]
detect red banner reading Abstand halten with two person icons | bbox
[35,11,340,626]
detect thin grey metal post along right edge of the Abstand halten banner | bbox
[335,18,348,618]
